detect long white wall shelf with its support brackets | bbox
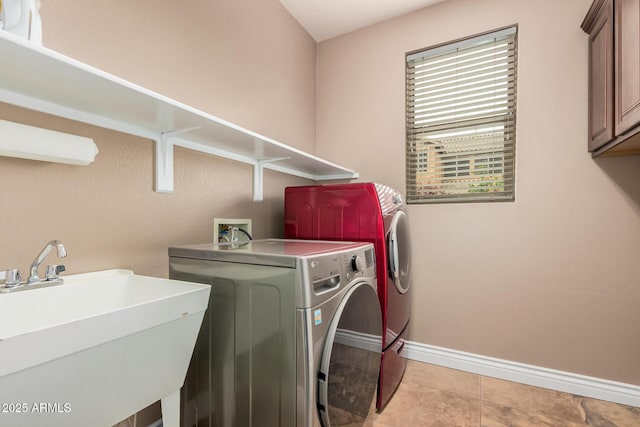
[0,31,358,201]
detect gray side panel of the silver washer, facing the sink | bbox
[169,257,298,427]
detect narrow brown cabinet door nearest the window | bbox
[589,0,613,151]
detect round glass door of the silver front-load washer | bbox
[318,282,382,427]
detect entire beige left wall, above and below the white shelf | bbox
[0,0,316,276]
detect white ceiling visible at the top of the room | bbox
[279,0,445,42]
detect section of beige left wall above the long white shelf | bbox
[42,0,316,152]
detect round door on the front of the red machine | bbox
[387,210,411,294]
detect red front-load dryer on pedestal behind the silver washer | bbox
[284,183,411,410]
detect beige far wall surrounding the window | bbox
[316,0,640,384]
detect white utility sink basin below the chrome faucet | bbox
[0,270,210,427]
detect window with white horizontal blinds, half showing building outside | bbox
[405,24,518,204]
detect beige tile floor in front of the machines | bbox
[373,360,640,427]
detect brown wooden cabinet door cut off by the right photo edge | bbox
[615,0,640,135]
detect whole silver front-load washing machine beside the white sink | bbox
[169,239,382,427]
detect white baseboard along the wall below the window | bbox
[404,341,640,407]
